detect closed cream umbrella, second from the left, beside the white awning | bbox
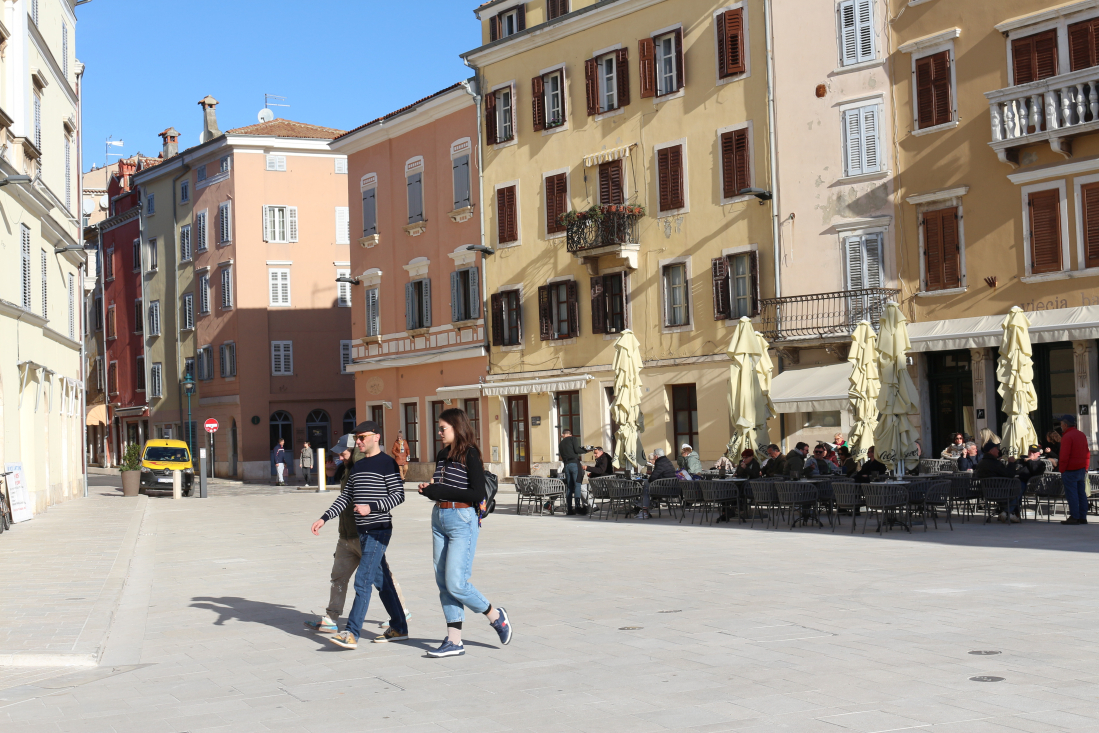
[725,316,775,463]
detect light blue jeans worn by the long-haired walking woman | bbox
[431,507,489,623]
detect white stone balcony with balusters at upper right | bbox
[985,66,1099,167]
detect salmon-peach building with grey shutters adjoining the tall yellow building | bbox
[331,82,488,476]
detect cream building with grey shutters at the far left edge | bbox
[0,0,87,513]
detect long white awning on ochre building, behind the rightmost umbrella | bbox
[908,301,1099,352]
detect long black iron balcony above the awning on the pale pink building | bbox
[759,288,900,342]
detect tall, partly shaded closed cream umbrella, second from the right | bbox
[874,302,920,475]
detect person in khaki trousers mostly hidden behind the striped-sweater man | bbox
[306,434,412,642]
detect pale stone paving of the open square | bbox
[0,485,1099,733]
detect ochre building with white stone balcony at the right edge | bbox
[889,0,1099,453]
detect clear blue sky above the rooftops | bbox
[76,0,480,170]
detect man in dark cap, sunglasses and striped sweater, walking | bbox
[312,420,408,649]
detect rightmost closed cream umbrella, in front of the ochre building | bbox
[996,306,1037,456]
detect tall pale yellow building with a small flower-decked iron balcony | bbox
[463,0,777,475]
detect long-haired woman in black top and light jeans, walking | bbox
[420,408,511,657]
